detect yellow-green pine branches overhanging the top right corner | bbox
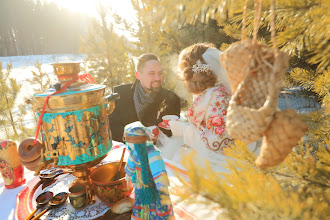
[148,0,330,107]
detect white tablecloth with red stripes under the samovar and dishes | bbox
[0,141,222,220]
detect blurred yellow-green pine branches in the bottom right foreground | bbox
[181,141,330,220]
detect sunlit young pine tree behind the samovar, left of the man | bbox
[80,4,134,88]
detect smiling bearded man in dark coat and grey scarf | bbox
[109,53,180,141]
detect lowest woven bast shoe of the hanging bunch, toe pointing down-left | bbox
[255,109,307,169]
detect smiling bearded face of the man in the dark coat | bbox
[136,60,163,93]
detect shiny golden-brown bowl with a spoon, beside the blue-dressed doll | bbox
[90,162,129,206]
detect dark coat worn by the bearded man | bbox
[109,81,180,141]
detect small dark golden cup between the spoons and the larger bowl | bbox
[69,184,87,210]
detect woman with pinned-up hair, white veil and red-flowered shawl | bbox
[160,43,237,171]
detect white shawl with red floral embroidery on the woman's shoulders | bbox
[185,84,233,153]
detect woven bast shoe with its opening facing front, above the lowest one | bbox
[225,41,289,143]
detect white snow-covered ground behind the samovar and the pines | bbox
[0,54,320,140]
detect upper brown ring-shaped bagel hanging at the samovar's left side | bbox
[18,137,42,162]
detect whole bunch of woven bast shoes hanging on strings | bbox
[221,0,307,168]
